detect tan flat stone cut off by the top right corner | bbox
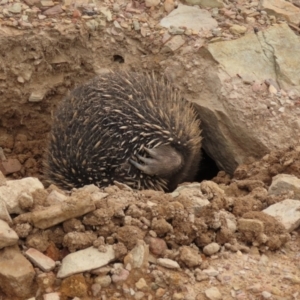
[260,0,300,26]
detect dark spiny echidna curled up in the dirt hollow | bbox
[45,72,201,191]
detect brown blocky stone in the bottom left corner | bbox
[0,246,35,299]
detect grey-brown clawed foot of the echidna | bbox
[129,145,183,178]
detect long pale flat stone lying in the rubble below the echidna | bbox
[57,245,115,278]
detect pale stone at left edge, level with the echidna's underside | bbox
[0,177,44,214]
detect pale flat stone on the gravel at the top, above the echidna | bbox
[160,4,218,31]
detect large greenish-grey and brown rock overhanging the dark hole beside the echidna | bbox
[193,24,300,174]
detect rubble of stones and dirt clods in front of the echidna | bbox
[0,147,300,300]
